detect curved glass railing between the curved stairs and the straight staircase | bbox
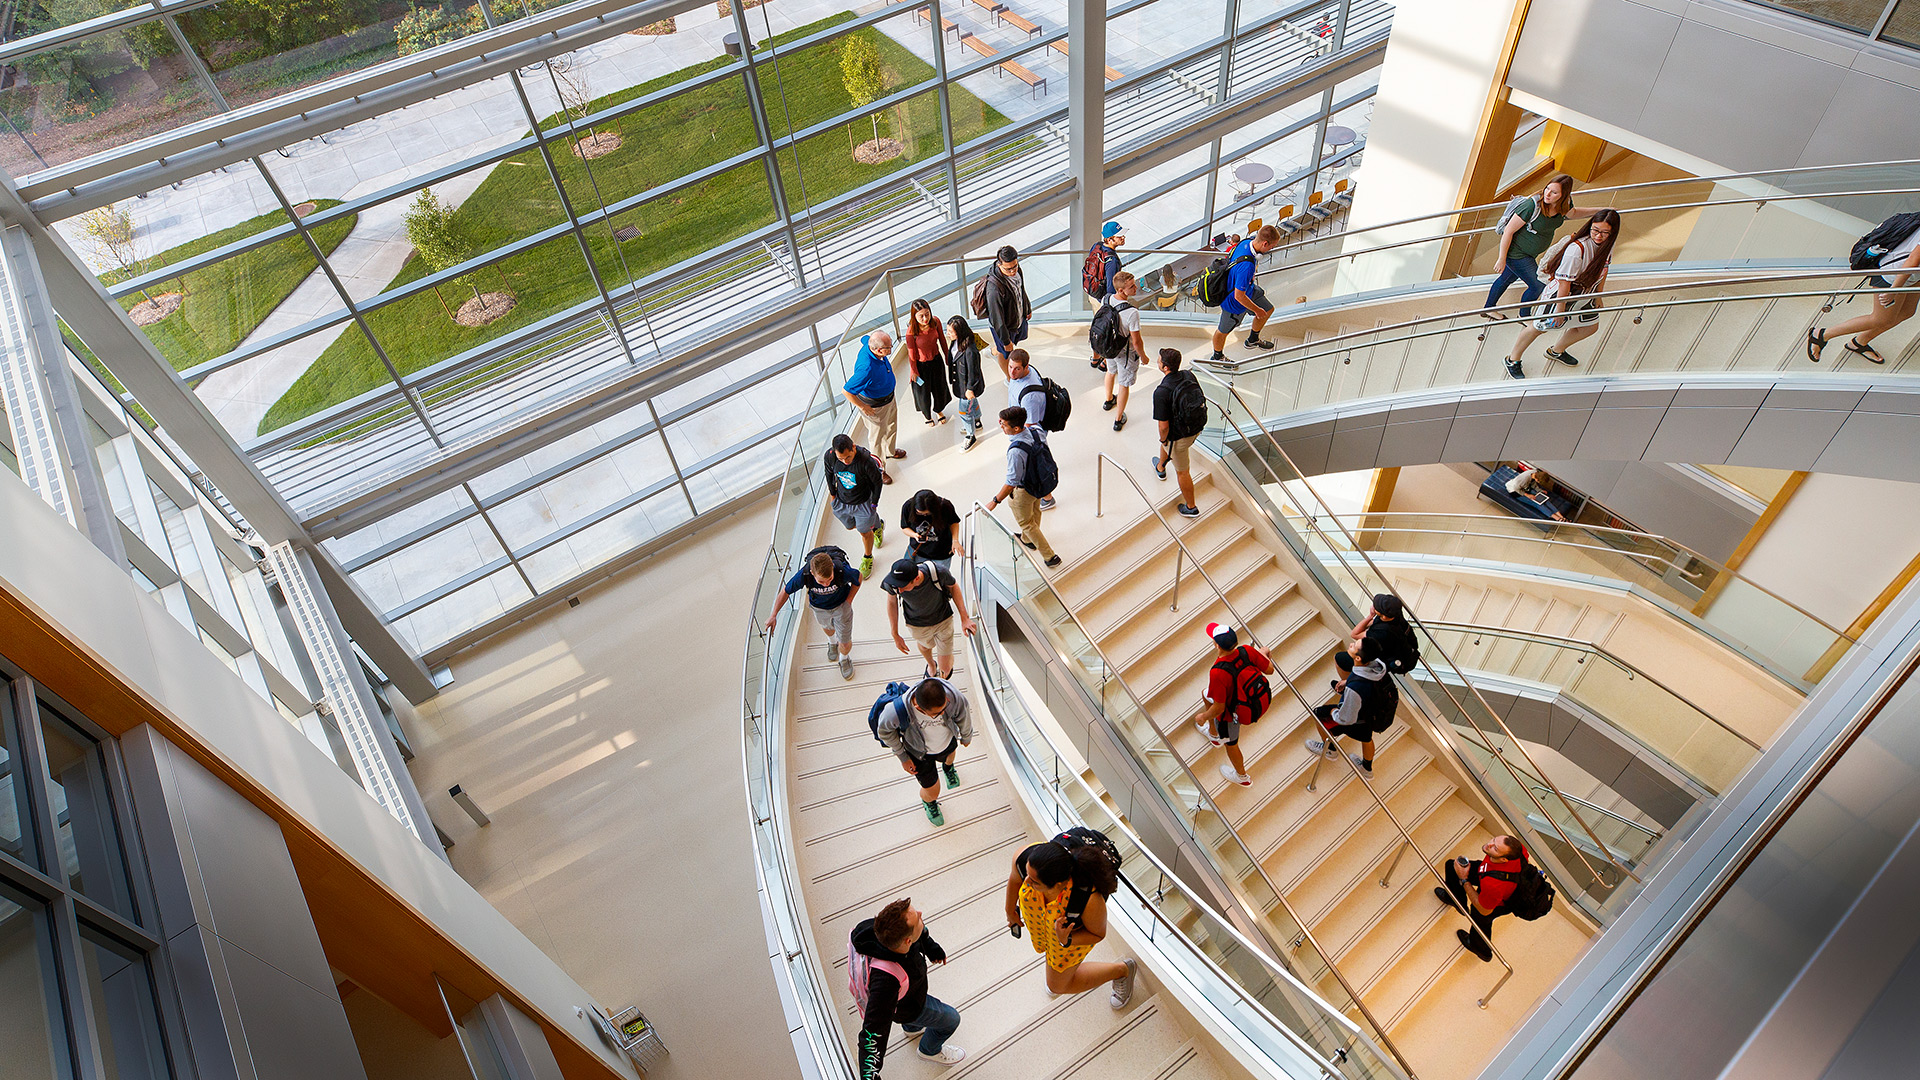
[964,513,1405,1080]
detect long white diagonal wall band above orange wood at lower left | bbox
[0,471,634,1076]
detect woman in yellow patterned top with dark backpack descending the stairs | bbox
[1006,830,1137,1009]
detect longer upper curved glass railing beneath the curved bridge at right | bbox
[1309,511,1855,692]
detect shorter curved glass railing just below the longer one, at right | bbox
[1425,619,1764,798]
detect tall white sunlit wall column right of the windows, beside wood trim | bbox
[1334,0,1515,296]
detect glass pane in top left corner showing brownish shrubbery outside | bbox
[0,24,217,177]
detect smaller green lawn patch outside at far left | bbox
[100,198,357,371]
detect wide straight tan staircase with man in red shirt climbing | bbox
[1052,455,1592,1076]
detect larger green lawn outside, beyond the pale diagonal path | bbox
[259,13,1008,434]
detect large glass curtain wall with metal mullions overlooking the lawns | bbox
[15,0,1392,653]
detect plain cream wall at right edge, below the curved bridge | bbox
[1740,473,1920,630]
